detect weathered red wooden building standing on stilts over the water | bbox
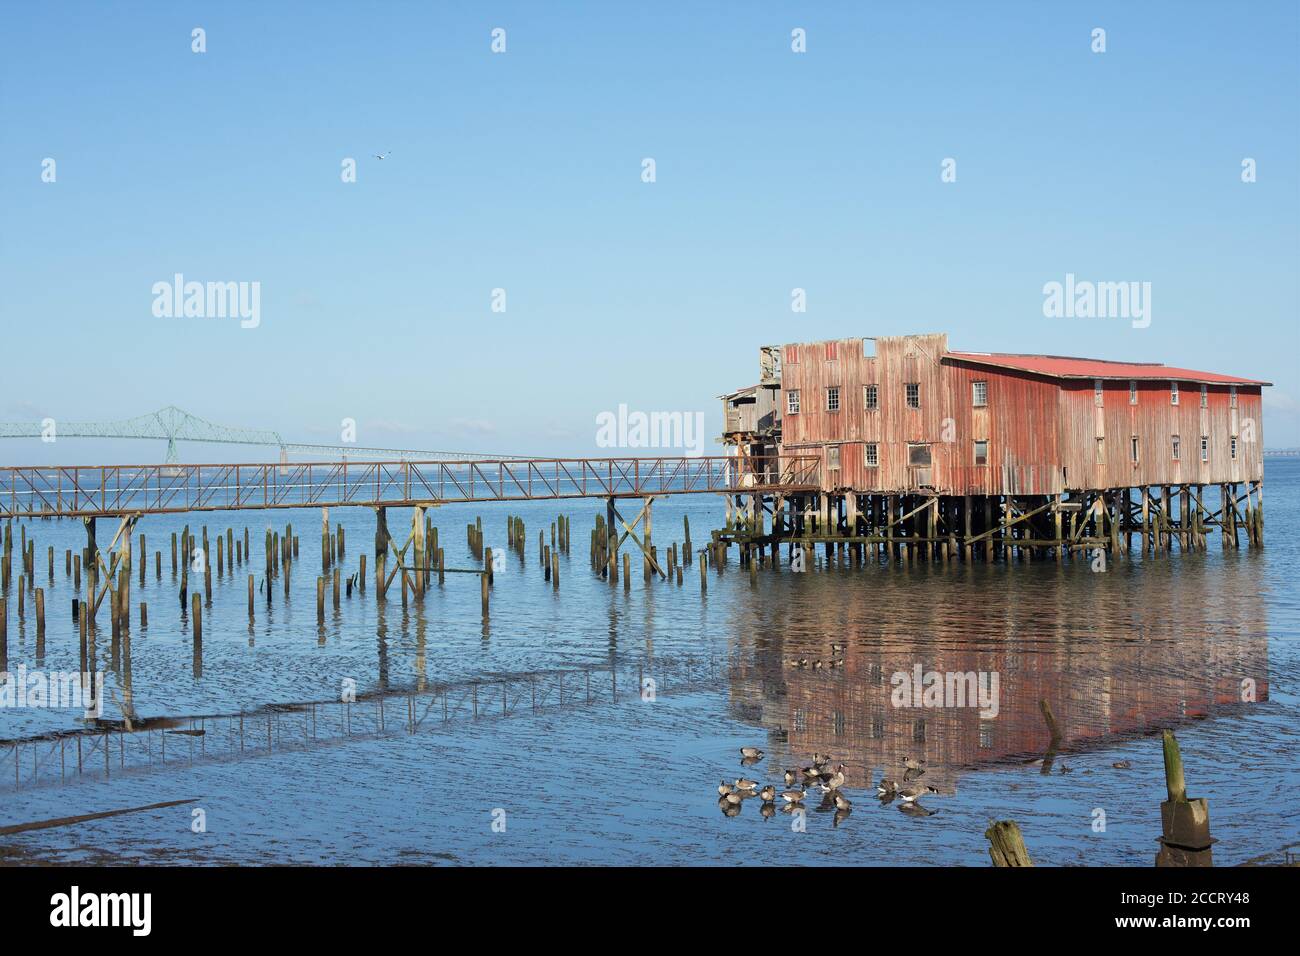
[716,333,1269,566]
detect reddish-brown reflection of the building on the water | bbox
[732,570,1269,790]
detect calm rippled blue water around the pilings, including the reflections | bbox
[0,459,1300,865]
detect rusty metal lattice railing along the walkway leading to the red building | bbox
[0,455,819,518]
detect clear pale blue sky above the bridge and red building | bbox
[0,0,1300,463]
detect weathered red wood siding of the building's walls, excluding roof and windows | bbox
[780,334,1262,494]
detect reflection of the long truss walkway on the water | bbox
[0,658,724,788]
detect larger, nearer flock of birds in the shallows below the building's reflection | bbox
[718,747,939,826]
